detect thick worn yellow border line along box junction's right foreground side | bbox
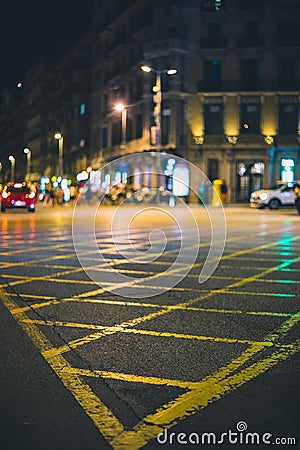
[111,313,300,450]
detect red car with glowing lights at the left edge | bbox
[1,182,36,212]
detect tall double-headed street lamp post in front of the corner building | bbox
[141,65,177,202]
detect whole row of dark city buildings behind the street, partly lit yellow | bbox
[0,0,300,203]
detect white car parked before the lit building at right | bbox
[250,181,300,209]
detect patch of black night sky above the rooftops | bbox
[0,0,93,88]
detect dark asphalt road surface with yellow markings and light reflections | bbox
[0,206,300,450]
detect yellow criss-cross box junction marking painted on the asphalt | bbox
[0,234,300,450]
